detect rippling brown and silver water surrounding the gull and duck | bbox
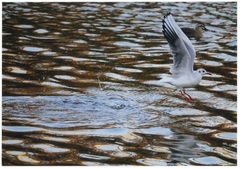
[2,2,237,165]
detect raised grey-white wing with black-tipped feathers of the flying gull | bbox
[162,13,196,76]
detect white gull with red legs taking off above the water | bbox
[160,12,211,102]
